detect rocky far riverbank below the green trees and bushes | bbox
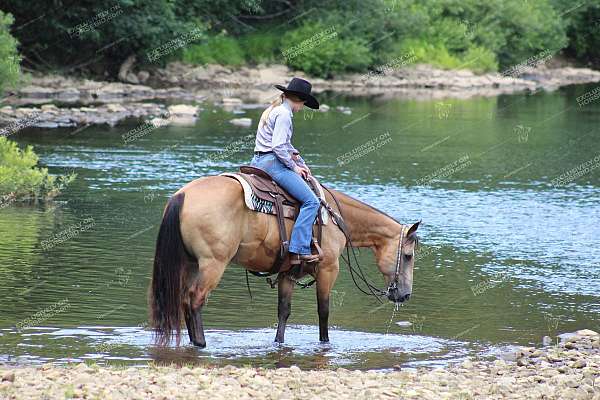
[0,62,600,132]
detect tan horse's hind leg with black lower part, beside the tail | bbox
[184,260,227,348]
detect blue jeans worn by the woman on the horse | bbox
[250,154,320,254]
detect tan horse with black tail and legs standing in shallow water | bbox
[148,175,420,348]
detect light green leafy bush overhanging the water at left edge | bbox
[0,137,76,200]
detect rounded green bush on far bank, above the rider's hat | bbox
[281,23,372,78]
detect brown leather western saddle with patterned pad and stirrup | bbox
[222,165,324,276]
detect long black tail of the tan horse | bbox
[148,193,186,346]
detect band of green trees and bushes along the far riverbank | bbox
[0,0,600,77]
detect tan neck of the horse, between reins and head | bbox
[335,191,401,247]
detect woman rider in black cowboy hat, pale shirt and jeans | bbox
[250,78,319,262]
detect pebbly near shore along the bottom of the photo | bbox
[0,329,600,399]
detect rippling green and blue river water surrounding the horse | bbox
[0,86,600,369]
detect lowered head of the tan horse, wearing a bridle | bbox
[375,221,421,303]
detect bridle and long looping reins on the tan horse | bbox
[321,184,408,303]
